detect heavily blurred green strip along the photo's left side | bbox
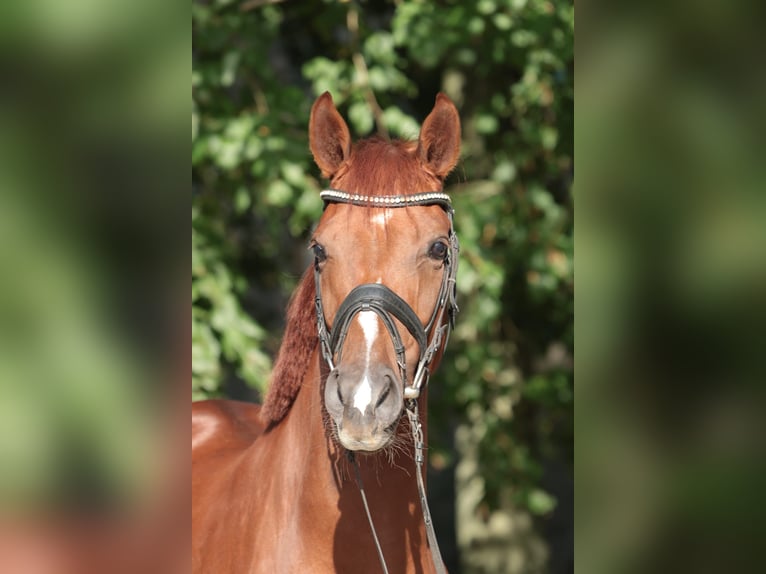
[0,0,186,536]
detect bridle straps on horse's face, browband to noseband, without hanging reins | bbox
[314,189,460,399]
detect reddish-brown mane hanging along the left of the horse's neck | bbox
[260,267,319,427]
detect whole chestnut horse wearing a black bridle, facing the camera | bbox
[192,93,460,574]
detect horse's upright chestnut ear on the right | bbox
[418,93,460,178]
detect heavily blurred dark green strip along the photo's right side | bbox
[576,0,766,574]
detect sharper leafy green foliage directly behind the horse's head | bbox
[192,0,574,536]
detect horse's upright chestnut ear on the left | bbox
[309,92,351,179]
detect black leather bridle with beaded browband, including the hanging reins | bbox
[314,189,460,574]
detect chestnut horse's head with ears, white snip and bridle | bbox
[309,93,460,451]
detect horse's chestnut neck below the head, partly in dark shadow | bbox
[270,350,438,572]
